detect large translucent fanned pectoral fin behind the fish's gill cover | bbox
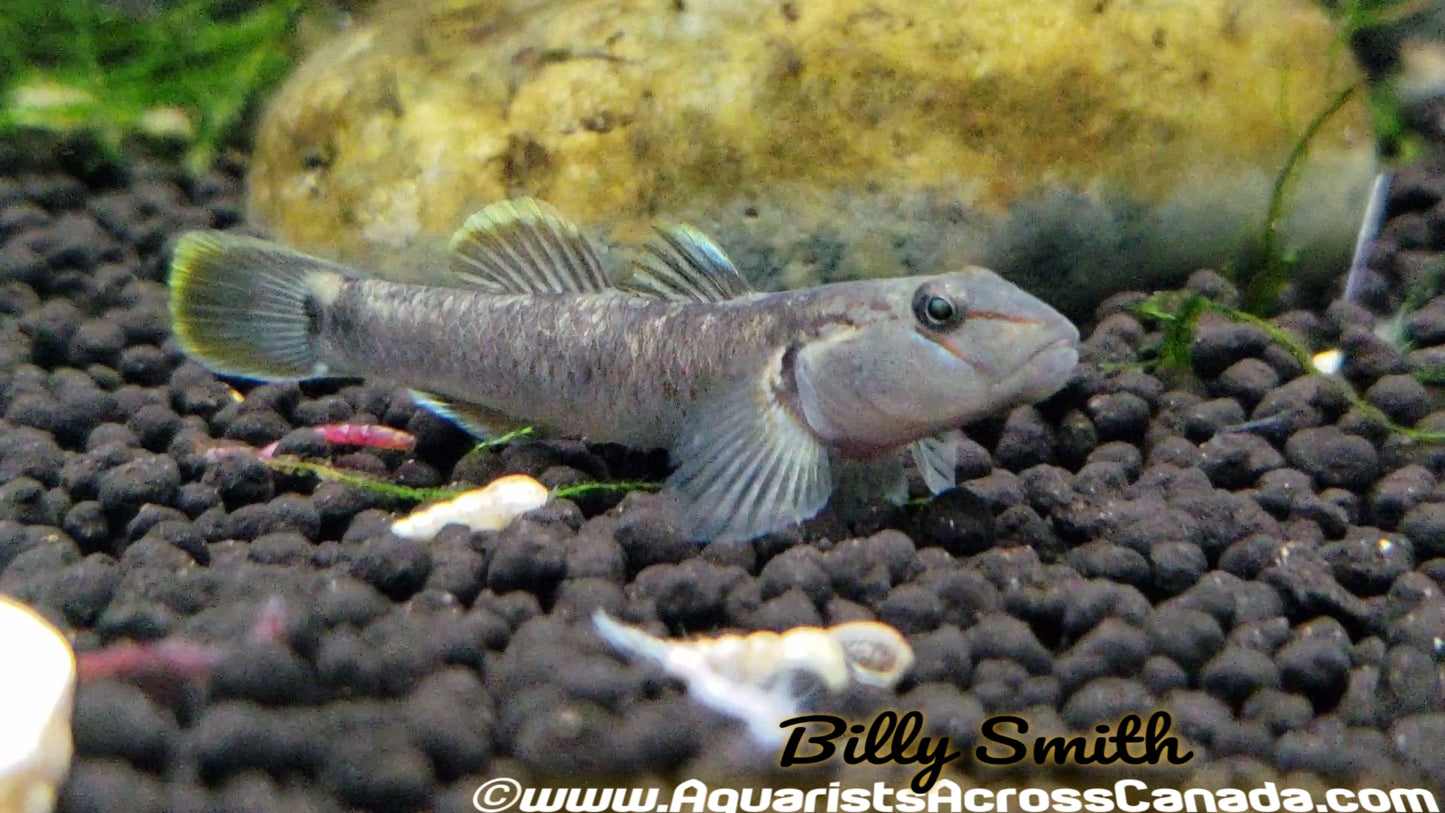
[668,360,832,542]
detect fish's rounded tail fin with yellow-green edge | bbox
[171,231,348,380]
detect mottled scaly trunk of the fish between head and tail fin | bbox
[325,280,786,449]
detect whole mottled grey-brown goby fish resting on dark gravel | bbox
[171,199,1078,540]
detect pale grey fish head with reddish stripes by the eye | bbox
[793,267,1079,458]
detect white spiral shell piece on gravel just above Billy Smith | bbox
[592,609,913,747]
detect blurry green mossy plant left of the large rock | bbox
[0,0,305,169]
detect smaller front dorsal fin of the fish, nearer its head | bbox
[620,225,753,302]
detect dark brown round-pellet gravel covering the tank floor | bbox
[0,136,1445,812]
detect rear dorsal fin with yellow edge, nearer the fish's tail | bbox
[451,198,611,293]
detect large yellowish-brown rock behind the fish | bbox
[250,0,1374,312]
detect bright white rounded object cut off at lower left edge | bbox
[0,596,75,813]
